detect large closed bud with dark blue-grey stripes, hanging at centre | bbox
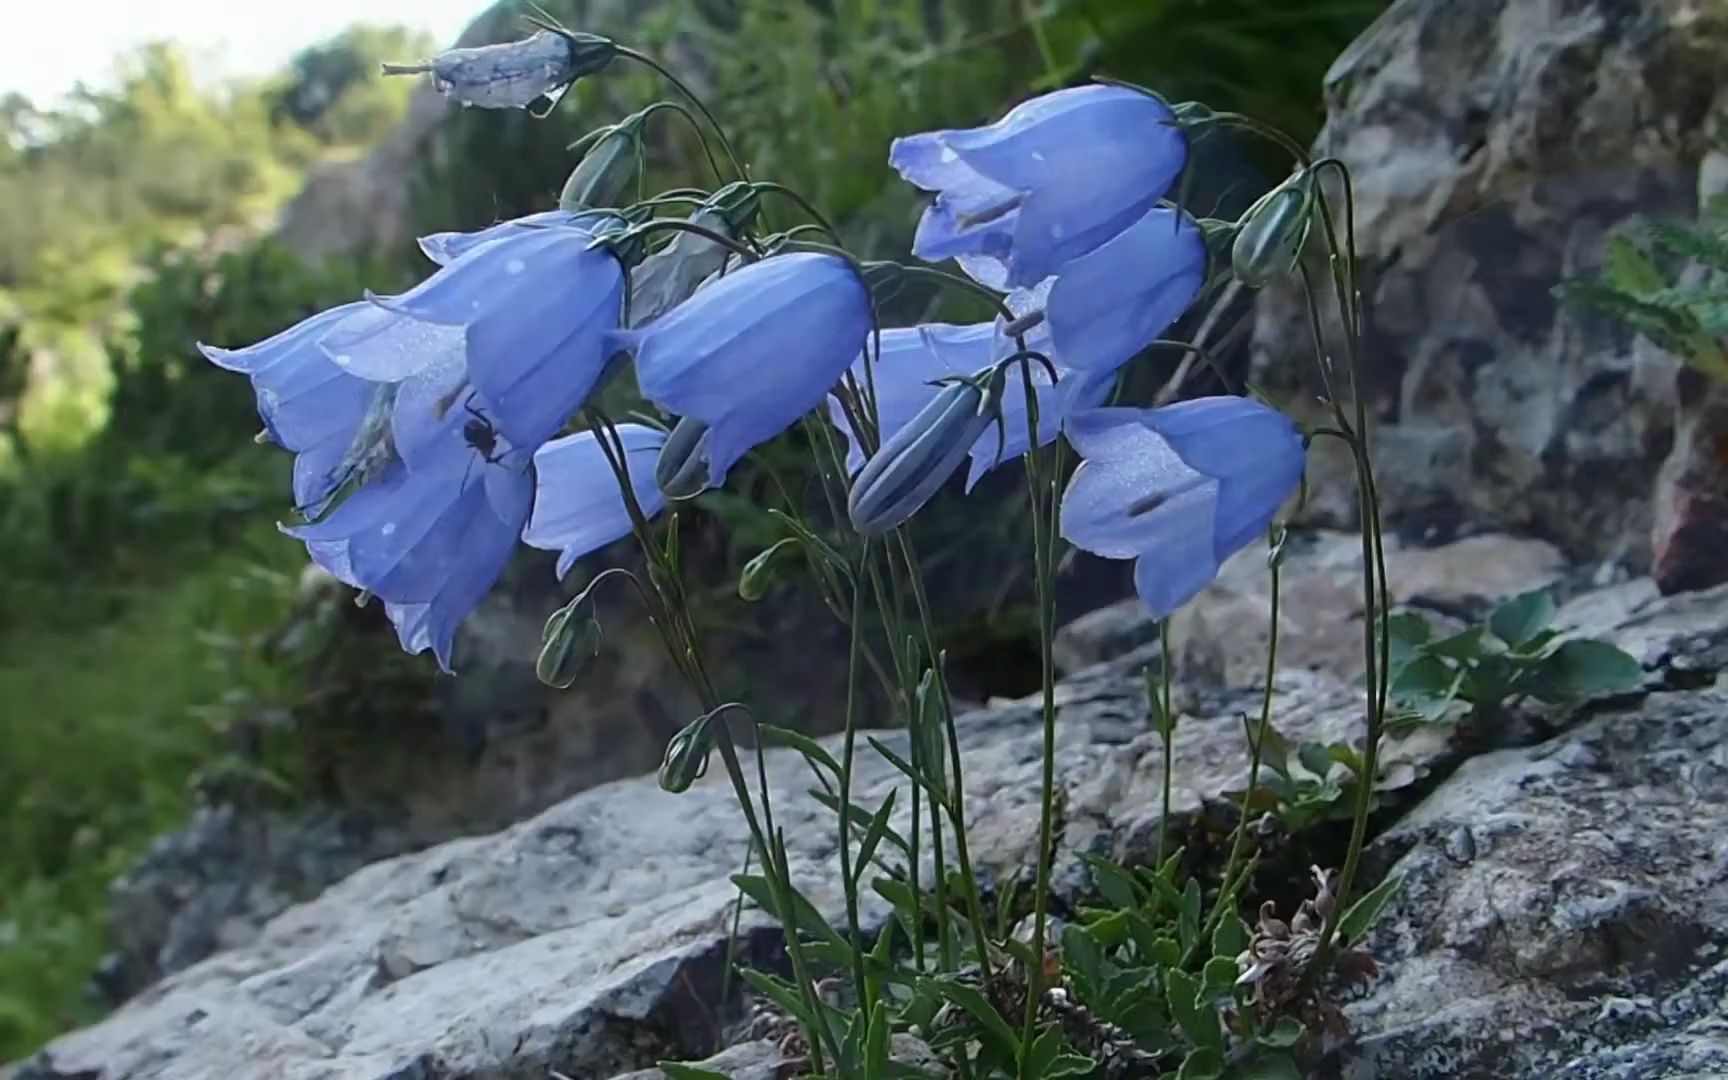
[847,370,1002,536]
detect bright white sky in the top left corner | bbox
[0,0,487,104]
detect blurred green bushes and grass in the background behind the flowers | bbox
[0,0,1382,1061]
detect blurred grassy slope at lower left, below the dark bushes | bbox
[0,520,302,1061]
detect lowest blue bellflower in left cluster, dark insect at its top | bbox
[283,399,534,670]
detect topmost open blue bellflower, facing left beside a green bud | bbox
[888,86,1187,289]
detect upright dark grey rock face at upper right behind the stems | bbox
[1255,0,1728,572]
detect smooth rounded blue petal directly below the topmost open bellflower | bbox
[1045,207,1206,370]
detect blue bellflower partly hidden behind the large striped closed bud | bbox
[828,323,1113,491]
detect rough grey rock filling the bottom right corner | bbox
[1339,582,1728,1080]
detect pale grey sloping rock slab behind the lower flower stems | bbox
[21,580,1452,1080]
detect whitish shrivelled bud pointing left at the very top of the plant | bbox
[384,29,617,109]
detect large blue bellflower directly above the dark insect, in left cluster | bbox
[320,221,624,451]
